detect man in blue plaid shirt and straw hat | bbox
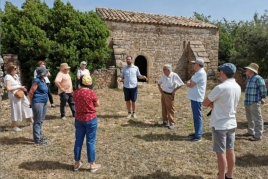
[244,63,267,141]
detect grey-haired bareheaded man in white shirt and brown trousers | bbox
[158,64,184,129]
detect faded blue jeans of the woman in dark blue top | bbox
[32,103,47,142]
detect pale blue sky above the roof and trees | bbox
[0,0,268,22]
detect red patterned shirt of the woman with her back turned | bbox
[73,88,98,122]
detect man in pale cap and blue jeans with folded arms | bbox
[187,58,207,142]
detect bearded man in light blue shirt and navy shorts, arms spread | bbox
[117,56,147,118]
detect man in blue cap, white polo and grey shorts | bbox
[203,63,241,179]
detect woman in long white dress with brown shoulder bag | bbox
[4,65,33,132]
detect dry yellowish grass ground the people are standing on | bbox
[0,84,268,179]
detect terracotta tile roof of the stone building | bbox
[96,8,218,28]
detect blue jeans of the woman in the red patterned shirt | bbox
[74,117,98,163]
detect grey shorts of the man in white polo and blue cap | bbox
[212,127,235,153]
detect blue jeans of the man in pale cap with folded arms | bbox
[191,100,203,139]
